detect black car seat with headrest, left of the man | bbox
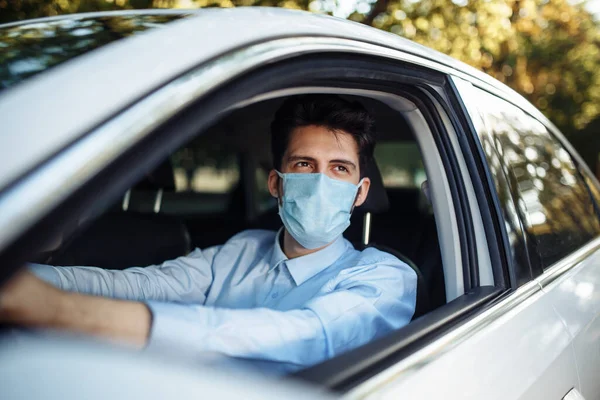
[46,161,191,269]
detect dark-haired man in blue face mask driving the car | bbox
[0,95,417,371]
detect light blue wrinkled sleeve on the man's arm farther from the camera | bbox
[28,246,221,304]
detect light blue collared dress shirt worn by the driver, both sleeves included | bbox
[30,230,417,372]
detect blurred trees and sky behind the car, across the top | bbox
[0,0,600,176]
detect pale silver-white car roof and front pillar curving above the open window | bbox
[0,7,528,190]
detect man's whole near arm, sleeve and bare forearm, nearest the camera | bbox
[0,266,416,368]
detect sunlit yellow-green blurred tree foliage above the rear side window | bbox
[350,0,600,135]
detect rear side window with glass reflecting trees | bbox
[468,91,600,268]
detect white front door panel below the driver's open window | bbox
[353,282,579,400]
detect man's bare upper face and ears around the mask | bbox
[269,125,370,206]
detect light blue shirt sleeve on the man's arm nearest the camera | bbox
[148,266,416,369]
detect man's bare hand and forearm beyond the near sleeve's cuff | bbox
[0,271,151,347]
